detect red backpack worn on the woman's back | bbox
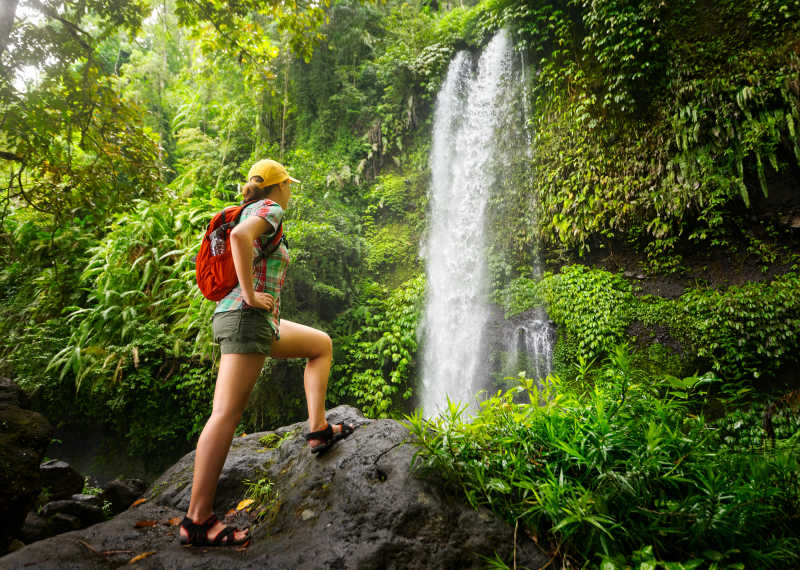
[195,200,286,301]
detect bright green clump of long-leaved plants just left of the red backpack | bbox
[51,194,212,388]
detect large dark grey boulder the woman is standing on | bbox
[0,406,547,570]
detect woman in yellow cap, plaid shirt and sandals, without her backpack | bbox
[180,160,354,546]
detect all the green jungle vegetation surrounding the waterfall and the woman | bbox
[0,0,800,568]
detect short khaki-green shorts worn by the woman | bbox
[213,309,275,355]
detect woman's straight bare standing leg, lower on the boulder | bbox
[181,354,266,540]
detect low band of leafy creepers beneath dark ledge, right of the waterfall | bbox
[498,265,800,381]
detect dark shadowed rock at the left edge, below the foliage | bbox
[0,378,53,553]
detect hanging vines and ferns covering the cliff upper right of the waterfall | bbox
[489,0,800,270]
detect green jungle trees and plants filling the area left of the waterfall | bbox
[0,1,450,440]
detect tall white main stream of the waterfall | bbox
[421,30,520,416]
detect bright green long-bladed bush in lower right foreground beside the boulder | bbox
[408,349,800,568]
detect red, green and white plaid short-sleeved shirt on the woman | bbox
[214,200,289,338]
